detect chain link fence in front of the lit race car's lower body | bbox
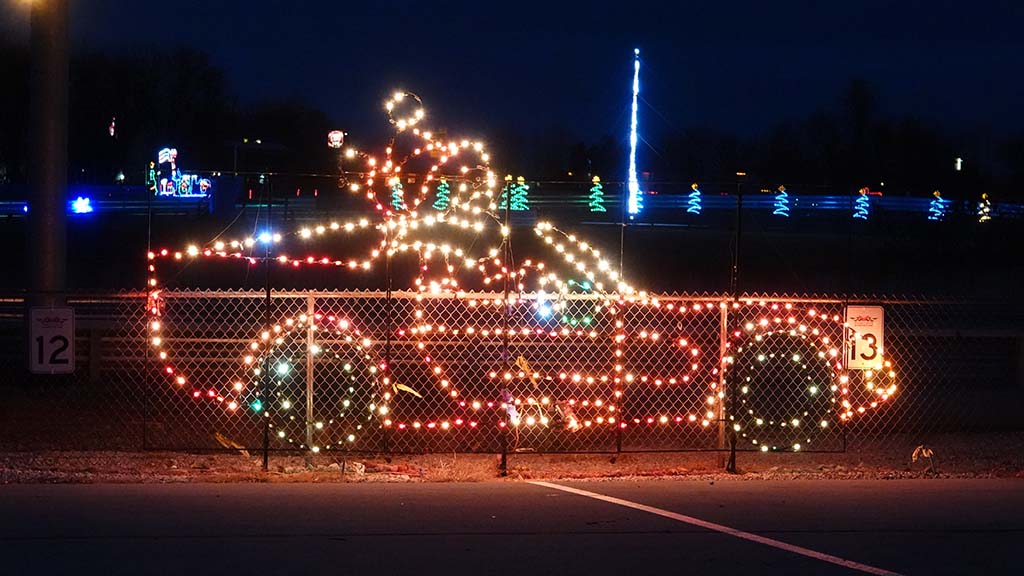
[0,290,1024,453]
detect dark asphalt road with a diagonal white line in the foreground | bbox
[0,480,1024,576]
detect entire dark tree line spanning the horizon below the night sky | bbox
[0,44,1024,198]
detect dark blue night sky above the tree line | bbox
[0,0,1024,139]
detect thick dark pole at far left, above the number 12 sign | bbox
[29,0,69,306]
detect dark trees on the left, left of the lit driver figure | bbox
[0,45,337,188]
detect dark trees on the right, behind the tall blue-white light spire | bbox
[545,81,1024,199]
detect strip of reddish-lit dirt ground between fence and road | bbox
[0,433,1024,484]
